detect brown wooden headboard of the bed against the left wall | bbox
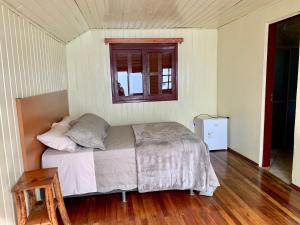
[16,91,69,171]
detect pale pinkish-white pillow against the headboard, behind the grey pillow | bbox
[37,121,77,152]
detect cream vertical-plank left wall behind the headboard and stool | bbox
[0,2,67,225]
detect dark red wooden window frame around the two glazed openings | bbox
[110,43,178,104]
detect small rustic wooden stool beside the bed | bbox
[11,168,71,225]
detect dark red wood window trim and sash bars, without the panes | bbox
[110,43,178,103]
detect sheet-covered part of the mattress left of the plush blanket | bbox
[42,125,137,196]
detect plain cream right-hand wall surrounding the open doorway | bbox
[218,0,300,185]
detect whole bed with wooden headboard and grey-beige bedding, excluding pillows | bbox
[17,91,219,201]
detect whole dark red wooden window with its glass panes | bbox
[110,44,177,103]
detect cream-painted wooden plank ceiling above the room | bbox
[4,0,278,42]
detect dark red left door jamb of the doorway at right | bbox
[262,23,277,167]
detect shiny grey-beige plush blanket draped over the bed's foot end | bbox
[132,122,219,196]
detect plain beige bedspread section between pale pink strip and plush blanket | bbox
[94,125,137,192]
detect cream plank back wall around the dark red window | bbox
[67,29,217,128]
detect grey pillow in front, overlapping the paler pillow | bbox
[66,113,110,150]
